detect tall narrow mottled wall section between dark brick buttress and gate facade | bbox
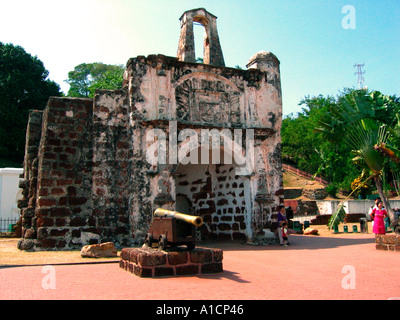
[90,90,132,245]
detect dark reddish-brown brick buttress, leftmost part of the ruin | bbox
[19,98,96,249]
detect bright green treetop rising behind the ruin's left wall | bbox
[66,62,125,98]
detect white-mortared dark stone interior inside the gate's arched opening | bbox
[174,153,252,240]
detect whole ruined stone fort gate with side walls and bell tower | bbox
[18,8,283,250]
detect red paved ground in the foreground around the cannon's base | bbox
[0,234,400,300]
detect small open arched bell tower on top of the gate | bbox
[177,8,225,67]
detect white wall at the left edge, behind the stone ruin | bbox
[0,168,23,219]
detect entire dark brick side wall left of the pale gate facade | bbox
[19,91,136,250]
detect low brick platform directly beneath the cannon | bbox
[119,247,223,278]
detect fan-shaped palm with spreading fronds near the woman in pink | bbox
[318,90,400,228]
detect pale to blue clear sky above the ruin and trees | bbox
[0,0,400,115]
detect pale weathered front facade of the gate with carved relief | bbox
[125,54,283,239]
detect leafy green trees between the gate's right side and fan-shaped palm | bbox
[281,95,360,190]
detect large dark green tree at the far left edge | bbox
[0,42,62,167]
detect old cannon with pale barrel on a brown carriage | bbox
[145,208,203,250]
